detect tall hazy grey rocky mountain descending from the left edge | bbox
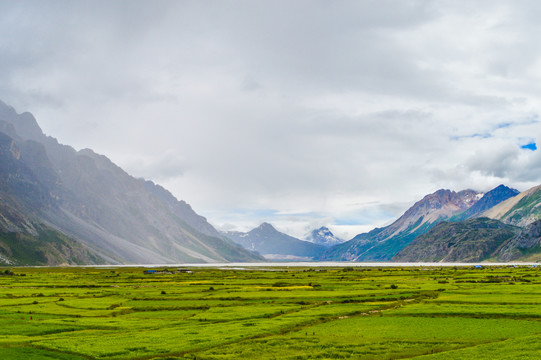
[0,102,263,264]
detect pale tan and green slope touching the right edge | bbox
[479,185,541,226]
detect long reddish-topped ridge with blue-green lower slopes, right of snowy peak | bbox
[321,189,482,261]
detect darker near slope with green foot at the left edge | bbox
[0,132,104,265]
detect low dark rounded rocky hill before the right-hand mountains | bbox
[392,218,521,262]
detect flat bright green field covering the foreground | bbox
[0,267,541,360]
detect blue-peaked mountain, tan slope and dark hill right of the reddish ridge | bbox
[392,185,541,262]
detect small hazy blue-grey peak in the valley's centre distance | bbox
[225,223,325,260]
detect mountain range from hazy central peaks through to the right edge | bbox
[226,185,541,262]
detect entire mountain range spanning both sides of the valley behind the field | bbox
[0,98,541,265]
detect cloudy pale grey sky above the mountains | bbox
[0,0,541,239]
